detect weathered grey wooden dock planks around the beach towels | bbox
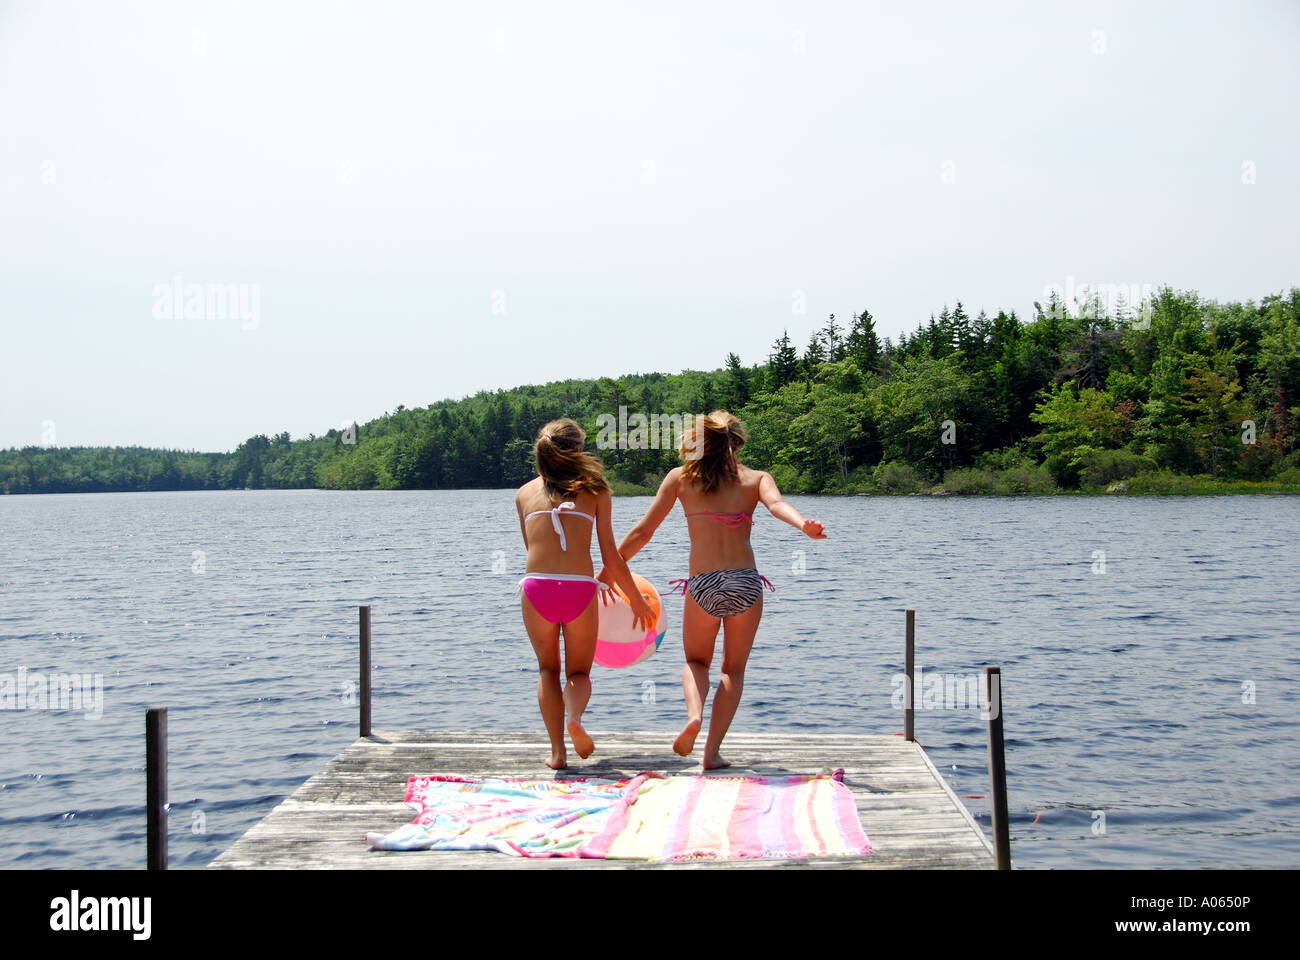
[209,730,993,870]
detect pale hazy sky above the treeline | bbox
[0,0,1300,450]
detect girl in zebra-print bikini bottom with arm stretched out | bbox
[598,410,826,770]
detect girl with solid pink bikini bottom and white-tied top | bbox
[515,420,655,770]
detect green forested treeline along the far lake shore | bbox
[0,287,1300,493]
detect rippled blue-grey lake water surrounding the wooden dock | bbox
[0,490,1300,868]
